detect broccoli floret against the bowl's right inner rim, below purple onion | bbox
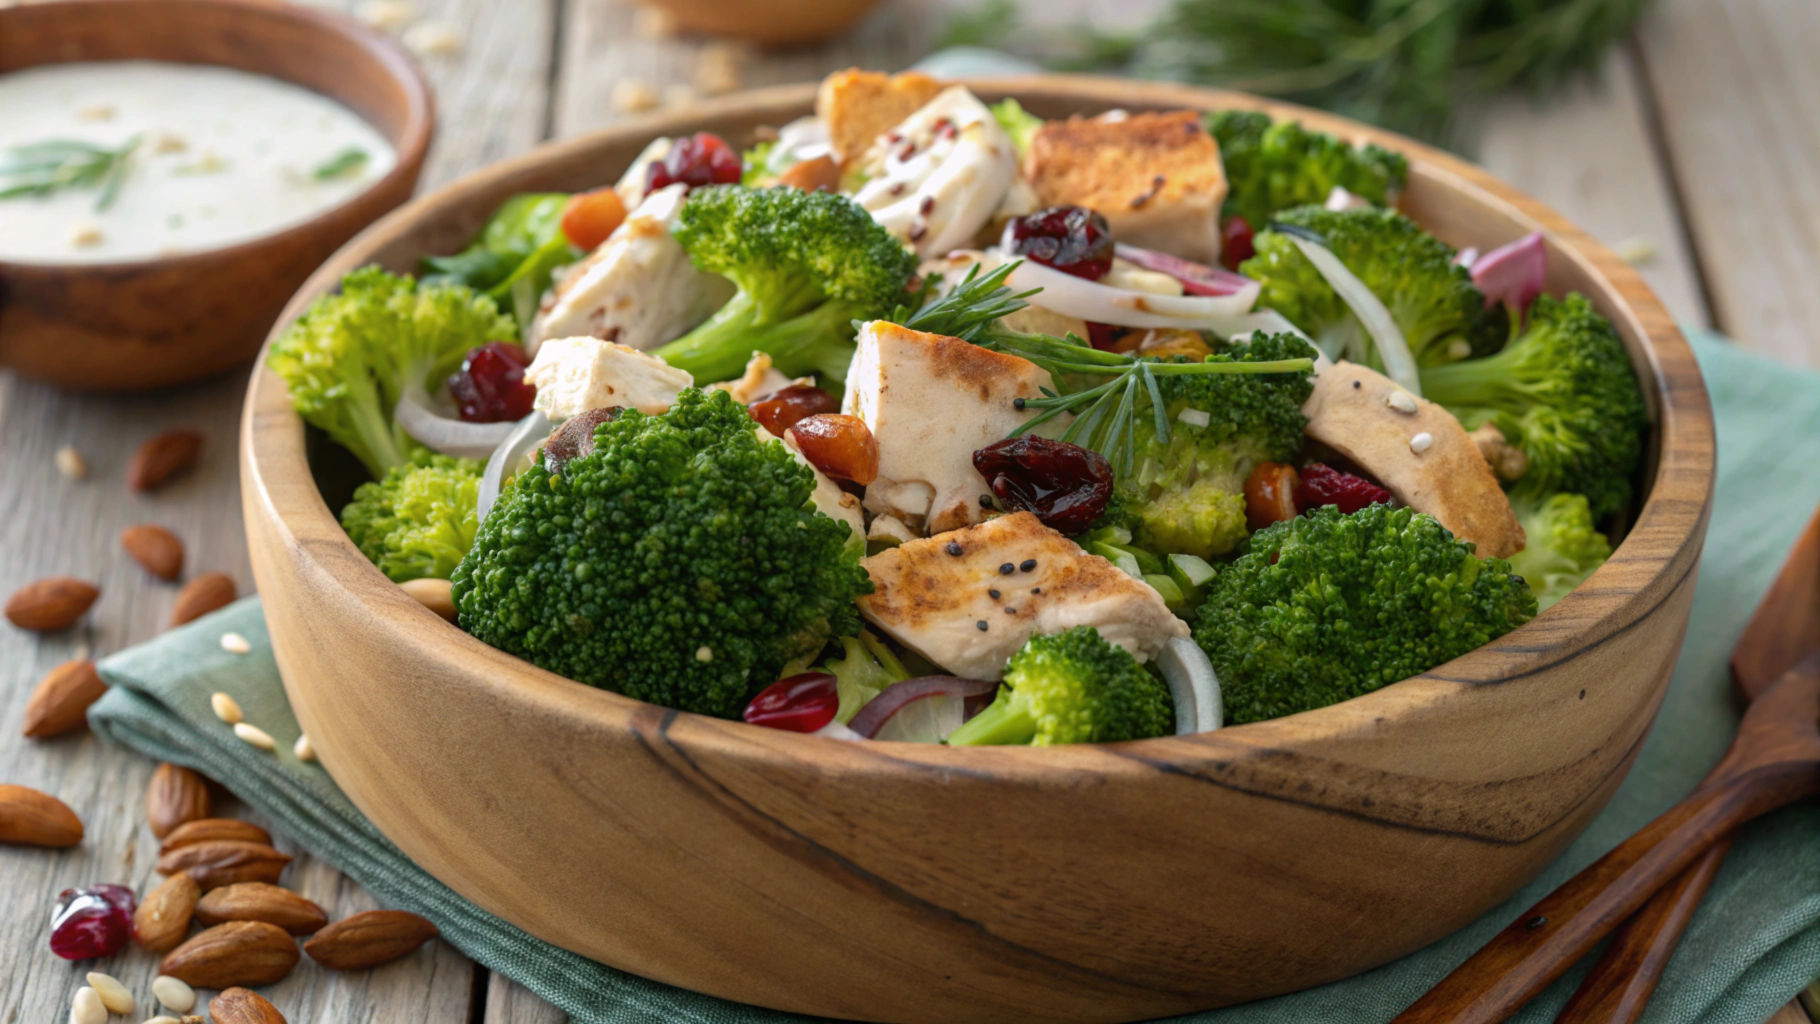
[1421,295,1649,520]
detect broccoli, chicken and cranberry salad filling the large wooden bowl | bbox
[269,71,1647,746]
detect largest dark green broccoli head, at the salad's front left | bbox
[451,389,872,718]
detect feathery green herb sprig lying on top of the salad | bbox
[890,260,1314,475]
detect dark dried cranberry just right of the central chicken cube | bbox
[974,437,1112,533]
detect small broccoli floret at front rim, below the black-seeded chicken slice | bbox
[948,626,1176,748]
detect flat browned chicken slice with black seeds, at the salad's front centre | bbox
[859,511,1188,678]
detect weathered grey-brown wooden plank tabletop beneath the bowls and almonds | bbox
[0,0,1820,1024]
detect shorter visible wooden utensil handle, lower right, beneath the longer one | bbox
[1554,837,1731,1024]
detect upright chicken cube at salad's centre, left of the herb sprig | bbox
[841,320,1050,533]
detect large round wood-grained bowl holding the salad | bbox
[242,76,1713,1024]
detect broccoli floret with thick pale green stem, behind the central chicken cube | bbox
[653,186,915,382]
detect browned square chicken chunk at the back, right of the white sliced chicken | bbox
[1023,111,1227,264]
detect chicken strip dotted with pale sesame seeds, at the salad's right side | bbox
[1301,362,1523,558]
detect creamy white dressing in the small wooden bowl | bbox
[0,60,397,264]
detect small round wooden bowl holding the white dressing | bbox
[0,0,435,391]
